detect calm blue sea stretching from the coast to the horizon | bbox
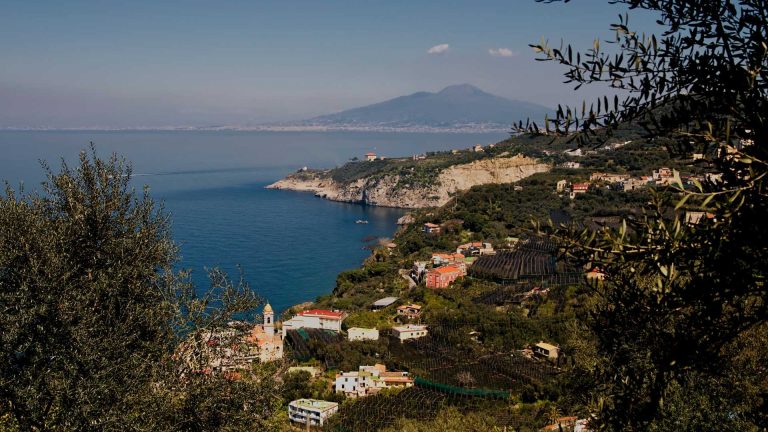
[0,131,507,313]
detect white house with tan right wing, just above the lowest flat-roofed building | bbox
[334,364,413,398]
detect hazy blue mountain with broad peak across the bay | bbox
[294,84,552,131]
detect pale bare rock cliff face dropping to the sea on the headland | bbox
[267,156,550,208]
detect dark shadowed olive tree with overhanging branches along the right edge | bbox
[518,0,768,430]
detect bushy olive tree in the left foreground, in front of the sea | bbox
[0,147,282,430]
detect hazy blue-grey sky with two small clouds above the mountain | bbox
[0,0,657,128]
